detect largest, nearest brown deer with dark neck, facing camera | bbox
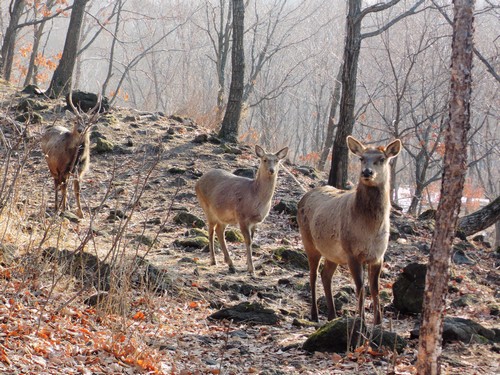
[297,136,402,325]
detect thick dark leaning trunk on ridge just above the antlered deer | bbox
[47,0,88,98]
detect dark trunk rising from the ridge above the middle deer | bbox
[219,0,245,142]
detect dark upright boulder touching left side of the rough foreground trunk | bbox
[392,263,427,314]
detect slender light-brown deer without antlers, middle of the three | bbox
[195,145,288,275]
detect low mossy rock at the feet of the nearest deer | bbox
[302,317,406,353]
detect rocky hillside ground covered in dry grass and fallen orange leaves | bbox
[0,84,500,375]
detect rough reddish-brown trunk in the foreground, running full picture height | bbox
[417,0,474,375]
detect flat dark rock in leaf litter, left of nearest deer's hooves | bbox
[209,302,280,325]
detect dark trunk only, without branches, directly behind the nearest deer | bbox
[328,0,361,189]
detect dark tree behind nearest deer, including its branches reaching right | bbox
[328,0,424,188]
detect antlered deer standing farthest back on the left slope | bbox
[41,95,100,218]
